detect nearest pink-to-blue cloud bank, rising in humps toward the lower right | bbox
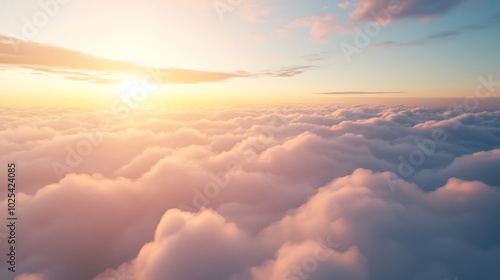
[96,169,500,280]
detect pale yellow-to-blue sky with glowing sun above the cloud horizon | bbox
[0,0,500,105]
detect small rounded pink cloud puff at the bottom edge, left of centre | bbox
[95,210,265,280]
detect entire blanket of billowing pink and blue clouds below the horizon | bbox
[0,105,500,280]
